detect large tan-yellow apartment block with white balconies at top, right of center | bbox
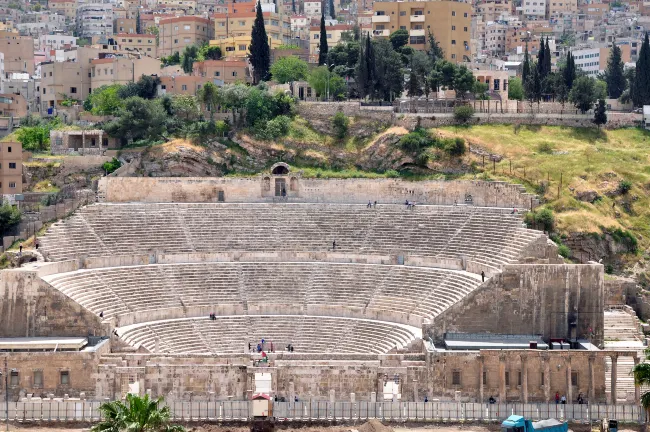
[372,1,472,62]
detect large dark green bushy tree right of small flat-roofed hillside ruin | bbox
[104,97,168,141]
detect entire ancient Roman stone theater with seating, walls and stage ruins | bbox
[0,163,644,420]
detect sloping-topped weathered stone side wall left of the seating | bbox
[0,269,104,337]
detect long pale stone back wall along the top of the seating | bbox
[99,173,539,208]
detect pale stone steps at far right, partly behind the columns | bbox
[604,306,646,402]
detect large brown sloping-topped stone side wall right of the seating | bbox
[428,264,605,344]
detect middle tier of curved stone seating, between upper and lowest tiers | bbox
[43,262,481,325]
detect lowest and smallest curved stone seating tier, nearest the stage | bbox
[118,315,421,354]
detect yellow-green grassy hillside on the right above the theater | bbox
[434,125,650,251]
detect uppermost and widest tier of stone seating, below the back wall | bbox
[40,203,542,266]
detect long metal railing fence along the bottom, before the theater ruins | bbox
[0,401,644,423]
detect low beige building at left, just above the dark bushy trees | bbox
[90,57,160,89]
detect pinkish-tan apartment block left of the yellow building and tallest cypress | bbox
[158,16,214,57]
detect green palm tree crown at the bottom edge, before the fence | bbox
[91,394,185,432]
